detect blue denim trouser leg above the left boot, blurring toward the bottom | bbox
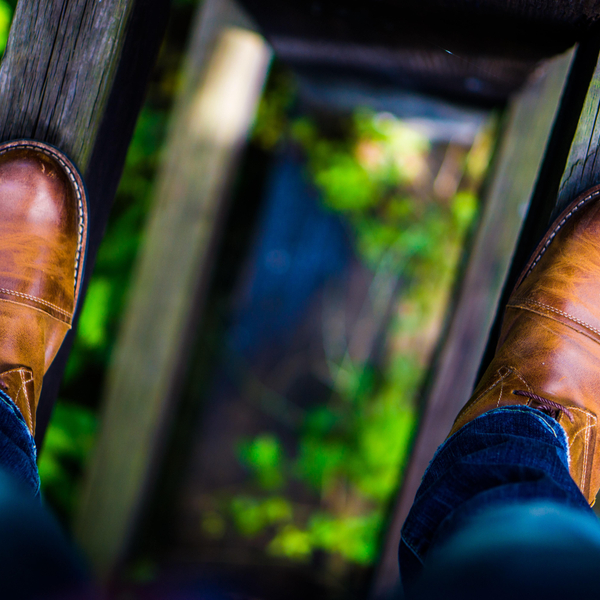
[0,390,92,600]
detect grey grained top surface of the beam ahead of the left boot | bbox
[0,0,134,171]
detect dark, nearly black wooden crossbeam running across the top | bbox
[237,0,600,106]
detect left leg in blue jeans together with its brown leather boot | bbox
[0,140,94,599]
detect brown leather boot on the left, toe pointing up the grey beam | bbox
[0,140,87,433]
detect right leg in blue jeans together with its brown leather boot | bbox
[400,188,600,598]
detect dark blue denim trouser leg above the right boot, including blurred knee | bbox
[399,406,600,600]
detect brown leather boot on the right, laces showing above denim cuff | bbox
[450,186,600,504]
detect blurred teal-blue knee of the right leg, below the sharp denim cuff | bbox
[407,500,600,600]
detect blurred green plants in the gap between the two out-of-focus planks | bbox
[202,71,493,565]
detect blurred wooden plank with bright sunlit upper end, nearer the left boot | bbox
[76,0,270,578]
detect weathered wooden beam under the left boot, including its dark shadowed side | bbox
[0,0,169,444]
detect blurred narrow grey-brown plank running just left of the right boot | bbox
[372,51,573,598]
